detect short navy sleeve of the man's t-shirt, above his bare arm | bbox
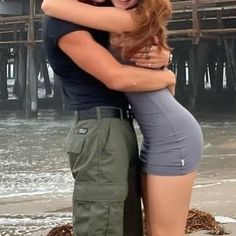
[43,16,87,45]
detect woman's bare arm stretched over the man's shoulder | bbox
[41,0,136,33]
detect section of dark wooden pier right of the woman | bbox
[169,0,236,111]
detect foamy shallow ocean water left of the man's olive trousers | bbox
[0,110,73,236]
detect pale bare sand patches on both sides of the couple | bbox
[12,181,236,236]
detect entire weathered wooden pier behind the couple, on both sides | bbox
[0,0,236,117]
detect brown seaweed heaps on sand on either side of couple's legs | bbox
[47,209,230,236]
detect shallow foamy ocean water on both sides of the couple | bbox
[0,110,236,236]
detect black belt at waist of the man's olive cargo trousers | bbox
[76,106,132,120]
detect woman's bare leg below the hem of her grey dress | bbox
[142,172,196,236]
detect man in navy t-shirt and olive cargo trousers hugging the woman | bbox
[43,1,175,236]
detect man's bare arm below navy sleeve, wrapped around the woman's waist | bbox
[58,31,176,92]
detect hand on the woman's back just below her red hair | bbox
[130,45,171,69]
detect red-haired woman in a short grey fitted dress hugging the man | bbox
[43,0,203,236]
